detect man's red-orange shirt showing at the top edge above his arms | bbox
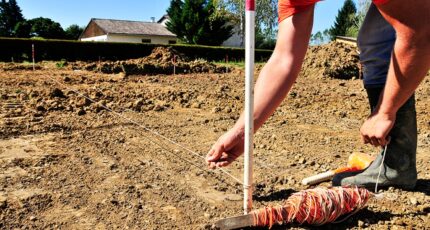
[278,0,389,23]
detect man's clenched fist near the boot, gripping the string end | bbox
[360,113,396,147]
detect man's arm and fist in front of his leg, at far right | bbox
[360,0,430,146]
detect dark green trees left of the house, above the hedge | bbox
[0,0,84,40]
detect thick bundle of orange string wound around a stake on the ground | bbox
[252,186,372,227]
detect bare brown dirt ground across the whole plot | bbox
[0,43,430,229]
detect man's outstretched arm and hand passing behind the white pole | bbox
[206,6,314,168]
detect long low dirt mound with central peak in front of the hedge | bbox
[84,47,228,75]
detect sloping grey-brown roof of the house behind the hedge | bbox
[91,18,176,37]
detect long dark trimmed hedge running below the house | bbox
[0,38,272,62]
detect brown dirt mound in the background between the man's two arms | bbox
[302,42,360,79]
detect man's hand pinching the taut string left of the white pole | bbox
[206,129,244,169]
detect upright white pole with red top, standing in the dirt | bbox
[243,0,255,214]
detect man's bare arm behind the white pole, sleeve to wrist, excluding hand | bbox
[235,7,313,131]
